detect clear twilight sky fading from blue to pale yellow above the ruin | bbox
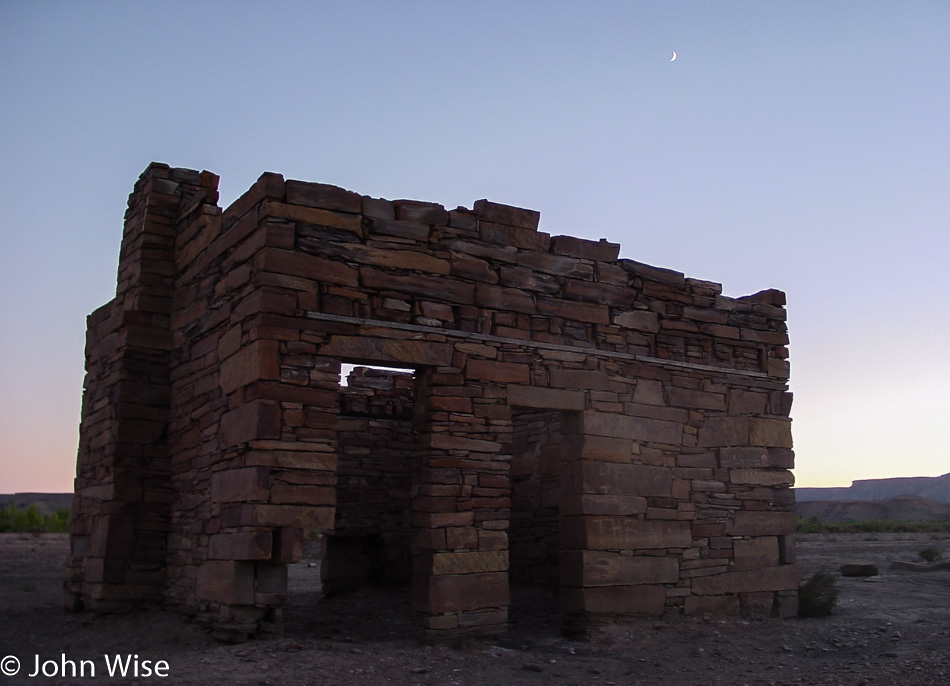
[0,0,950,493]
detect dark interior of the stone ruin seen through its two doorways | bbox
[324,365,577,636]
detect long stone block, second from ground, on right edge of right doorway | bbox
[560,550,679,587]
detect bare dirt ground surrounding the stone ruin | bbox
[0,534,950,686]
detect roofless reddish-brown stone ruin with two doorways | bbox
[66,163,798,640]
